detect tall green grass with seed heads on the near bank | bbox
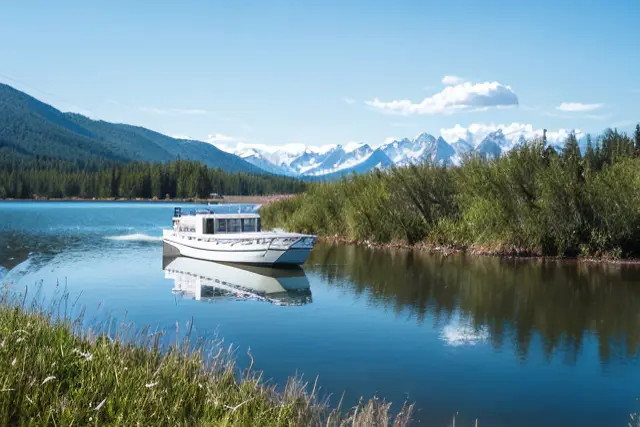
[0,295,413,426]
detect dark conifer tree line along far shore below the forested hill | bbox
[0,157,305,199]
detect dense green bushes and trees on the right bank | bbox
[262,125,640,262]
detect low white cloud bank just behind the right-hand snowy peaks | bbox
[440,122,584,145]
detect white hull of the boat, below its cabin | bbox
[163,237,311,265]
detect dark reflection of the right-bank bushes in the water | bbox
[308,245,640,364]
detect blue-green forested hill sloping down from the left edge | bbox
[0,84,263,173]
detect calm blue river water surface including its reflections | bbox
[0,202,640,427]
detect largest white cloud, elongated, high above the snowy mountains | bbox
[366,82,518,116]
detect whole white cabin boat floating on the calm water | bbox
[162,204,316,265]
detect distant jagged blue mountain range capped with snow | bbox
[218,129,581,178]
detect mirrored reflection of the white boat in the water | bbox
[162,251,311,306]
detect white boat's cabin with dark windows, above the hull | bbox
[173,204,261,234]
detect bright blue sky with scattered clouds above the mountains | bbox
[0,0,640,146]
